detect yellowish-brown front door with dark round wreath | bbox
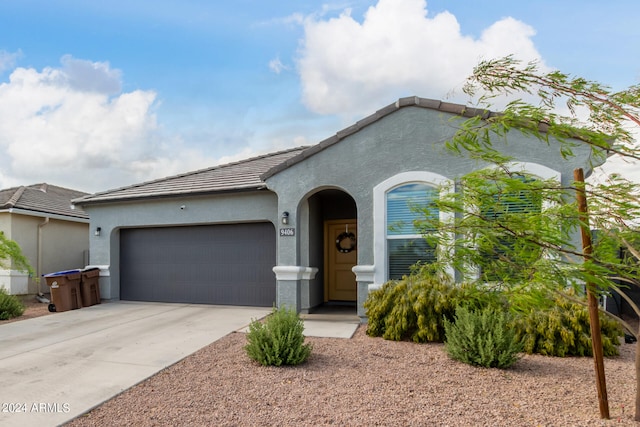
[324,219,358,301]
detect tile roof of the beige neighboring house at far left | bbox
[0,183,89,219]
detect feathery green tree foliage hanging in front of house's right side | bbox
[420,56,640,421]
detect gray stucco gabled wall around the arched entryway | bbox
[266,107,590,314]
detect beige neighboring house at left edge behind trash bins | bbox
[0,184,89,295]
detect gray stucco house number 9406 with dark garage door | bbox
[74,97,604,317]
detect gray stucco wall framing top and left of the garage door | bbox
[84,190,278,299]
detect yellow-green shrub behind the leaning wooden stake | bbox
[515,296,624,357]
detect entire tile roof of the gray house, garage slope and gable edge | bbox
[73,96,494,205]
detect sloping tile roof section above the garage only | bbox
[73,147,307,205]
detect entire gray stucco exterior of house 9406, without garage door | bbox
[77,98,594,317]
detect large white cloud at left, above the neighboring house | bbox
[0,56,216,191]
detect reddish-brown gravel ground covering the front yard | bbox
[0,305,640,426]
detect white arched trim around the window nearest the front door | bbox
[373,171,454,283]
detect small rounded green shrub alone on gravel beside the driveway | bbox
[244,308,312,366]
